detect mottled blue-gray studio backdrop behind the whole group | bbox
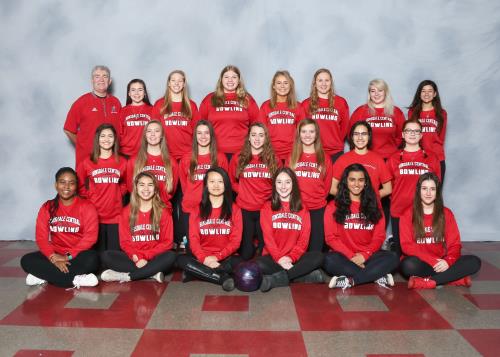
[0,0,500,240]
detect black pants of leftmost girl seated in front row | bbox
[21,250,99,288]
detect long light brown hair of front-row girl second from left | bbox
[129,171,165,233]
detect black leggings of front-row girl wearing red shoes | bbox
[401,255,481,285]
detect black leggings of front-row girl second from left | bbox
[101,250,176,280]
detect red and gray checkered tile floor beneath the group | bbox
[0,241,500,357]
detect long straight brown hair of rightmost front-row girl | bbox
[412,172,445,243]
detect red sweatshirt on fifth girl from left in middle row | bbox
[287,153,332,210]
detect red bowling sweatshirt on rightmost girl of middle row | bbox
[387,150,441,217]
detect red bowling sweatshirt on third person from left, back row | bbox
[152,98,200,161]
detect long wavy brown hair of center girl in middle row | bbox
[236,123,278,178]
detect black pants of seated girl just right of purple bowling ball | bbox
[255,252,323,280]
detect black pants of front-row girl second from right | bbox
[323,250,399,285]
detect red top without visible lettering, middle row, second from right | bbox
[333,150,392,197]
